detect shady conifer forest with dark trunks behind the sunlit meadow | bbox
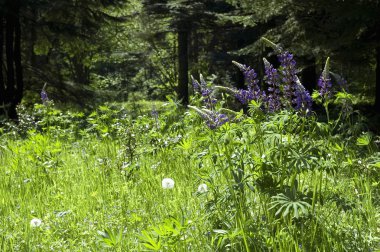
[0,0,380,123]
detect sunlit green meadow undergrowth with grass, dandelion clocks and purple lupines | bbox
[0,41,380,251]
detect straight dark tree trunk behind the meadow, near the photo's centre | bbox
[178,30,189,106]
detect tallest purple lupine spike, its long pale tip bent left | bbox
[277,51,299,101]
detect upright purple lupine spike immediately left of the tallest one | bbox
[263,58,281,112]
